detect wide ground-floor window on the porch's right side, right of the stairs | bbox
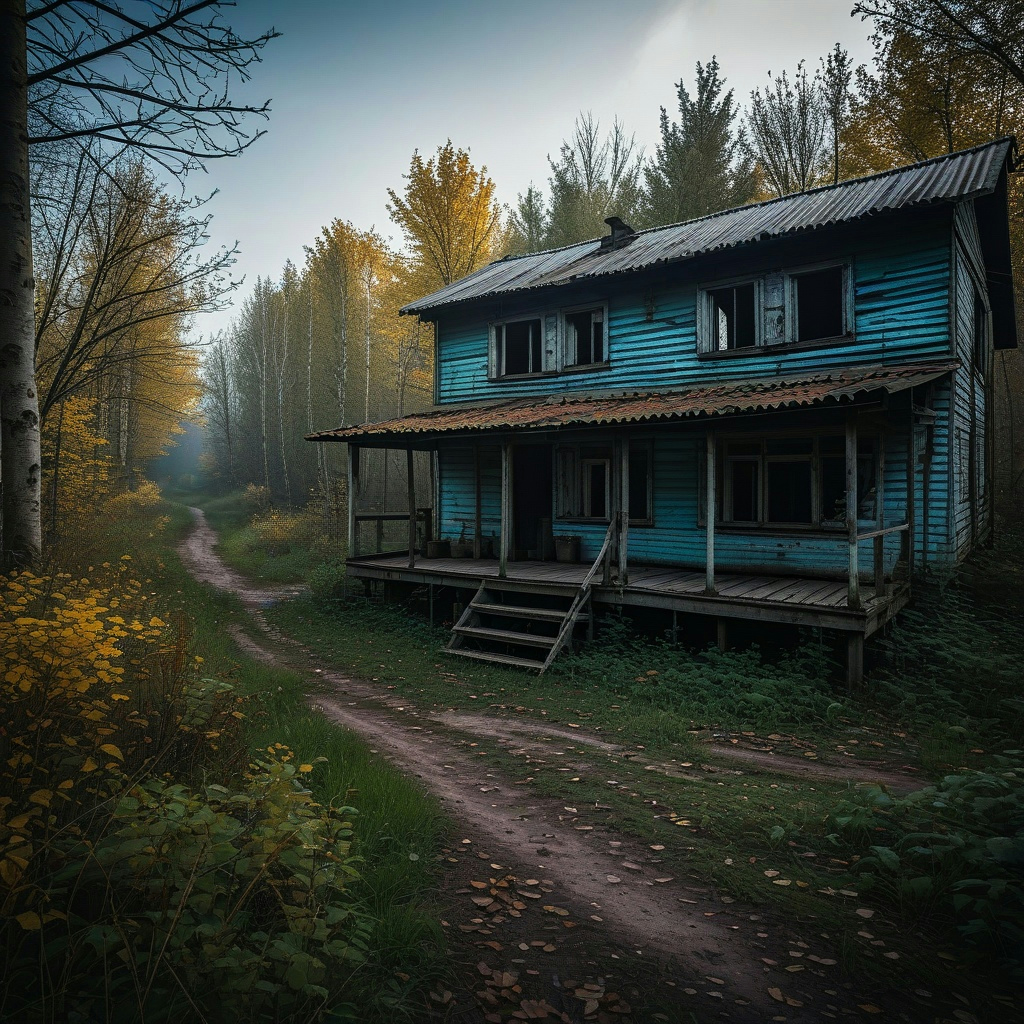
[700,434,878,528]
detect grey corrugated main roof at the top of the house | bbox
[401,138,1014,313]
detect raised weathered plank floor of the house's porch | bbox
[347,553,909,637]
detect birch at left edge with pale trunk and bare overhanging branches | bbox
[0,0,275,566]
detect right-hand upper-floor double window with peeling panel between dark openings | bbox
[697,263,853,354]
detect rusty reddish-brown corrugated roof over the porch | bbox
[306,362,956,444]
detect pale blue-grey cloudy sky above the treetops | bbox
[192,0,872,338]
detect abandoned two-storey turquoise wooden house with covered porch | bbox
[310,139,1017,683]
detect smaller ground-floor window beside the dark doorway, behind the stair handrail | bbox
[555,443,652,524]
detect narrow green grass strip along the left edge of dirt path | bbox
[65,496,447,1021]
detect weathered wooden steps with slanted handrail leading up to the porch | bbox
[445,525,612,674]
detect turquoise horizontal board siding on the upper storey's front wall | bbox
[437,213,950,403]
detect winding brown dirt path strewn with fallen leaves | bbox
[179,509,929,1022]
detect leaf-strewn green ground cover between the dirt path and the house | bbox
[193,487,1024,1015]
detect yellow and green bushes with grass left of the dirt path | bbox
[0,488,441,1022]
